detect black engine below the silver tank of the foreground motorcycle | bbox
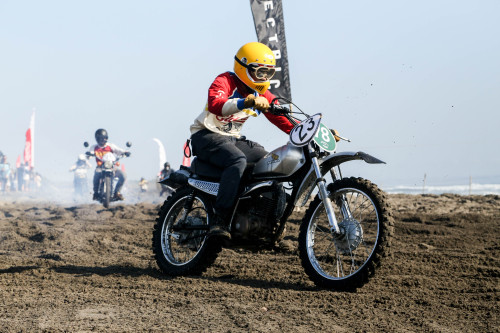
[233,183,286,239]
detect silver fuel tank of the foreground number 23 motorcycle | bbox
[253,142,306,179]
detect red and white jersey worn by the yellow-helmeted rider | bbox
[190,72,293,137]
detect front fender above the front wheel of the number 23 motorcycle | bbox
[295,151,385,207]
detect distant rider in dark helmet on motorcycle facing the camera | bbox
[89,128,130,201]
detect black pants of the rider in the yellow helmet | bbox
[191,129,267,214]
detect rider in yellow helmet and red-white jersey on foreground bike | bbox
[190,42,293,239]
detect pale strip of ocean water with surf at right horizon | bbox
[384,183,500,195]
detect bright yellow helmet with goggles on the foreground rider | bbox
[234,42,276,94]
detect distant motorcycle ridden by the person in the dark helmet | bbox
[83,142,132,208]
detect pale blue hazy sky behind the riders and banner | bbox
[0,0,500,187]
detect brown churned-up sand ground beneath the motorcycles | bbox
[0,191,500,332]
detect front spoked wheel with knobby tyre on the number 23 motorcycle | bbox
[299,178,394,290]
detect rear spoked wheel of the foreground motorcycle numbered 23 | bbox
[153,188,221,276]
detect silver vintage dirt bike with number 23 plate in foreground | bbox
[152,101,394,290]
